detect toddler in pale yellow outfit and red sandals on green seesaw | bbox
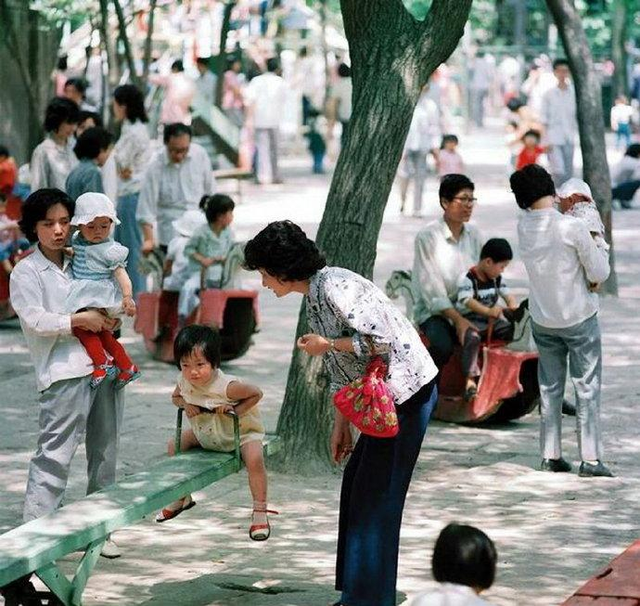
[156,324,276,541]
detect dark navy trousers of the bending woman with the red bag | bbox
[336,381,438,606]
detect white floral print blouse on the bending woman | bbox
[305,267,438,405]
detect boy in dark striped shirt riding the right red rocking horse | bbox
[457,238,517,402]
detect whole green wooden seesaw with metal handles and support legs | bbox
[0,409,280,606]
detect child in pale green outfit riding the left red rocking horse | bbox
[178,194,235,326]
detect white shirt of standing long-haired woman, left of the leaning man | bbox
[111,120,151,196]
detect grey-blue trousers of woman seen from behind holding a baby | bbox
[532,315,602,461]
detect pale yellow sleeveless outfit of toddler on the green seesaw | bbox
[178,369,264,452]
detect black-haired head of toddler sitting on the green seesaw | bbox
[173,324,220,386]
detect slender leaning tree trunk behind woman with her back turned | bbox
[547,0,618,295]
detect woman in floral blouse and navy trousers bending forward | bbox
[245,221,437,606]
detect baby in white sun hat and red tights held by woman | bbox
[67,193,140,389]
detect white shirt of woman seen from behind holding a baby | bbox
[518,208,609,328]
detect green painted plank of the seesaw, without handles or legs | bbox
[0,436,280,587]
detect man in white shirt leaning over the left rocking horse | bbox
[136,123,215,254]
